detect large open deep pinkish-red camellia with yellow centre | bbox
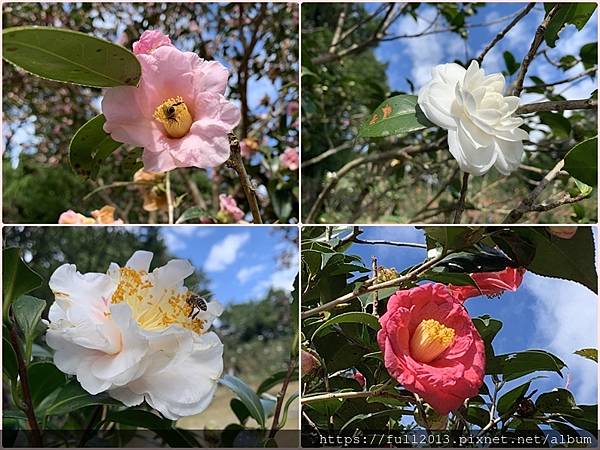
[377,283,485,415]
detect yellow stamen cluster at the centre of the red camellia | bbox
[410,319,455,363]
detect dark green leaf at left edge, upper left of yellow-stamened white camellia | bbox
[2,247,42,318]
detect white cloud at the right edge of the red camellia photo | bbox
[524,273,598,403]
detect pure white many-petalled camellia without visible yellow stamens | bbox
[418,61,529,175]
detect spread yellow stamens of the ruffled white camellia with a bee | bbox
[112,267,204,334]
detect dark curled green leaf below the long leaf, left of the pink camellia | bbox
[69,114,121,178]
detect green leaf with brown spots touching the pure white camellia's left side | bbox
[358,95,435,137]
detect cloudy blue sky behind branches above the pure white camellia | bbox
[368,3,598,103]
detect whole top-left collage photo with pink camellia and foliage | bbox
[3,4,298,224]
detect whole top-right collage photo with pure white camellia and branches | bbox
[302,3,598,223]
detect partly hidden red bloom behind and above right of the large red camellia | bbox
[448,267,525,302]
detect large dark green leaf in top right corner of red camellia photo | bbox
[517,227,598,293]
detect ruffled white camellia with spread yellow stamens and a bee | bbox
[46,251,223,420]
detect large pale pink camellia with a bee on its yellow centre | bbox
[102,32,240,172]
